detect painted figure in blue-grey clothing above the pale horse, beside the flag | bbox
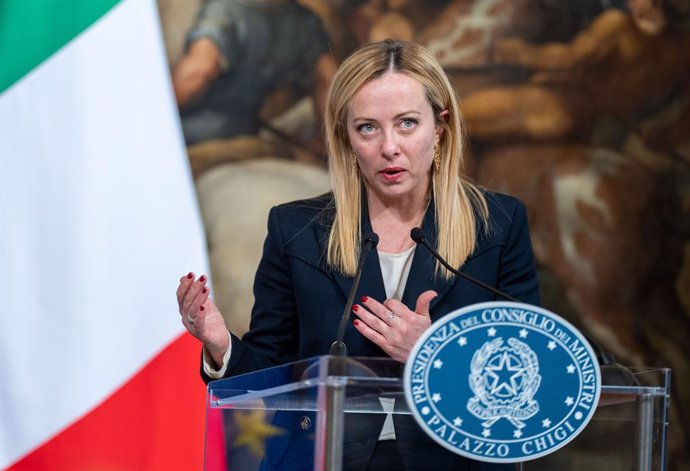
[173,0,336,151]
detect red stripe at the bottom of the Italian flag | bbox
[6,334,206,471]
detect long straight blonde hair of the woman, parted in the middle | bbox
[324,39,489,278]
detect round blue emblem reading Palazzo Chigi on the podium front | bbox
[404,301,601,463]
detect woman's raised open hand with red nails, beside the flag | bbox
[177,272,229,367]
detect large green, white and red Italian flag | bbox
[0,0,208,471]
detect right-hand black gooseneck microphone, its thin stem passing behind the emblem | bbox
[410,227,638,386]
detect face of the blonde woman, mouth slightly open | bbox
[347,72,442,204]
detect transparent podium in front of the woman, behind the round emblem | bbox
[204,356,671,471]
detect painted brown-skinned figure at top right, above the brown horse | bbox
[456,0,690,139]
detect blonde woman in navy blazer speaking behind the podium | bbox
[177,40,539,469]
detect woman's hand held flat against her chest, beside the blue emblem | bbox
[352,290,438,363]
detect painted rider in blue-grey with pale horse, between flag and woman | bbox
[173,0,336,332]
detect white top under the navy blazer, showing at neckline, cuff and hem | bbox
[203,246,415,440]
